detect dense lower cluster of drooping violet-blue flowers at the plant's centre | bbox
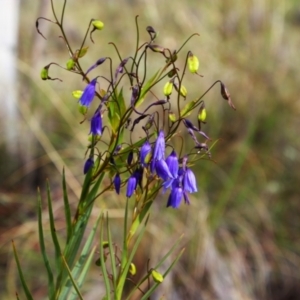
[114,130,197,208]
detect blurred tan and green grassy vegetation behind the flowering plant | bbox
[0,0,300,300]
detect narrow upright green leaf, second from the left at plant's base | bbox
[38,189,55,299]
